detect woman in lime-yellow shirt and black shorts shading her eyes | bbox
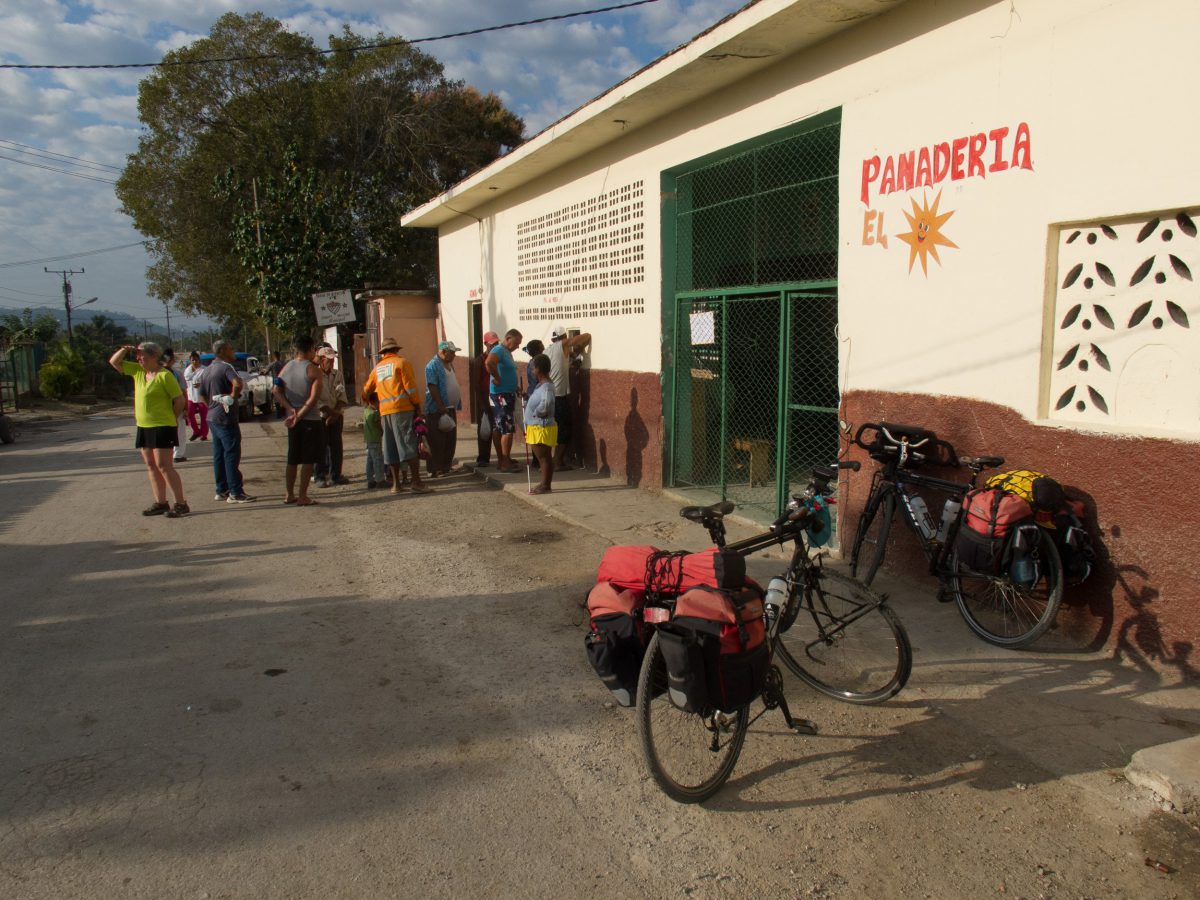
[108,341,192,518]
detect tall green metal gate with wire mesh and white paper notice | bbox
[664,113,840,516]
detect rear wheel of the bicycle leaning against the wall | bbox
[949,535,1062,648]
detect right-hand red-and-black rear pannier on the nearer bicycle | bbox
[658,587,770,714]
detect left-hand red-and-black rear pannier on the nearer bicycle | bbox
[583,581,646,707]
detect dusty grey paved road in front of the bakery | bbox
[0,418,1200,898]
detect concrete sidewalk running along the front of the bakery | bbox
[451,426,1200,818]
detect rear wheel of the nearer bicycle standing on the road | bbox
[637,634,750,803]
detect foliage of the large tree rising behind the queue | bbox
[118,13,523,326]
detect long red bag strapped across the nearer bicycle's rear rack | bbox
[596,546,746,593]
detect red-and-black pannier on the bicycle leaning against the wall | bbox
[954,487,1040,586]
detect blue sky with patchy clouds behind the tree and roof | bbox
[0,0,746,328]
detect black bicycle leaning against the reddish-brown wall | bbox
[850,422,1063,648]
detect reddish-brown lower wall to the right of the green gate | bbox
[841,391,1200,677]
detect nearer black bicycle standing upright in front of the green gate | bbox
[636,462,912,803]
